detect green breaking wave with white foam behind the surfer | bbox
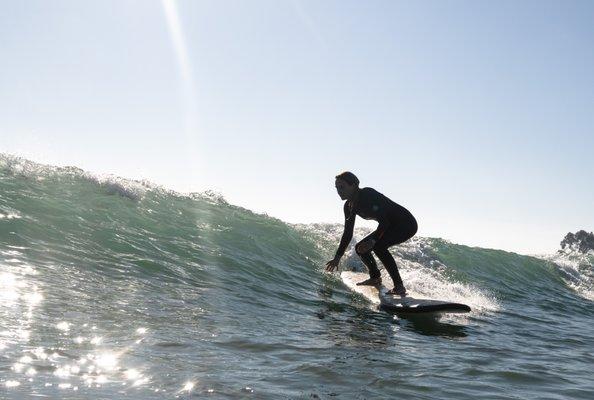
[0,155,594,313]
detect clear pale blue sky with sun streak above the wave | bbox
[0,0,594,254]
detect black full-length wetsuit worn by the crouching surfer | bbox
[336,188,418,285]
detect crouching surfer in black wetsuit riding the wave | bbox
[326,172,418,297]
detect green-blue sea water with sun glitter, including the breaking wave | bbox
[0,155,594,399]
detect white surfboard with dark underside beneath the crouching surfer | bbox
[340,271,470,315]
